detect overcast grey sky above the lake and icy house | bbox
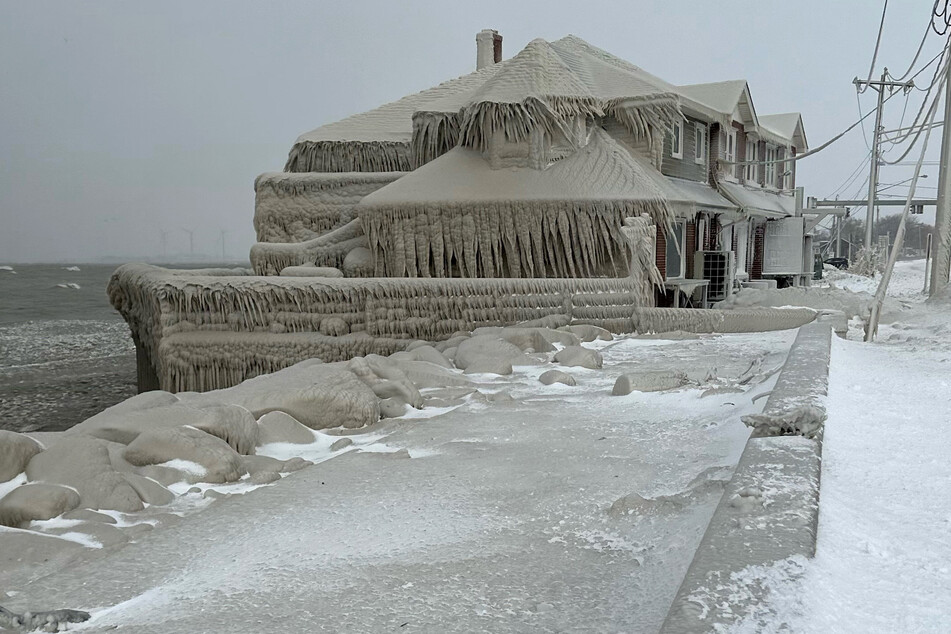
[0,0,940,263]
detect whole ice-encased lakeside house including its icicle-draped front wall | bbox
[110,31,805,390]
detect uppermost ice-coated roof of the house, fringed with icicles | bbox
[285,35,679,171]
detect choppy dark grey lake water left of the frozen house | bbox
[0,262,245,431]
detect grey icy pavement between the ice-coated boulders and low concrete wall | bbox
[7,331,795,632]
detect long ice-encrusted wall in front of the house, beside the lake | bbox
[109,264,815,390]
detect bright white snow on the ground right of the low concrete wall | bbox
[734,260,951,634]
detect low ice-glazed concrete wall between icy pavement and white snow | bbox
[661,320,832,634]
